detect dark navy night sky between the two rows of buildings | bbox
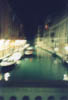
[10,0,67,38]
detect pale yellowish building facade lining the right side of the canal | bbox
[35,9,68,56]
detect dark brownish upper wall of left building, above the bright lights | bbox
[0,0,23,39]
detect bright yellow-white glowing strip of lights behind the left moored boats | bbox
[0,39,29,61]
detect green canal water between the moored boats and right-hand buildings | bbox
[0,48,68,85]
